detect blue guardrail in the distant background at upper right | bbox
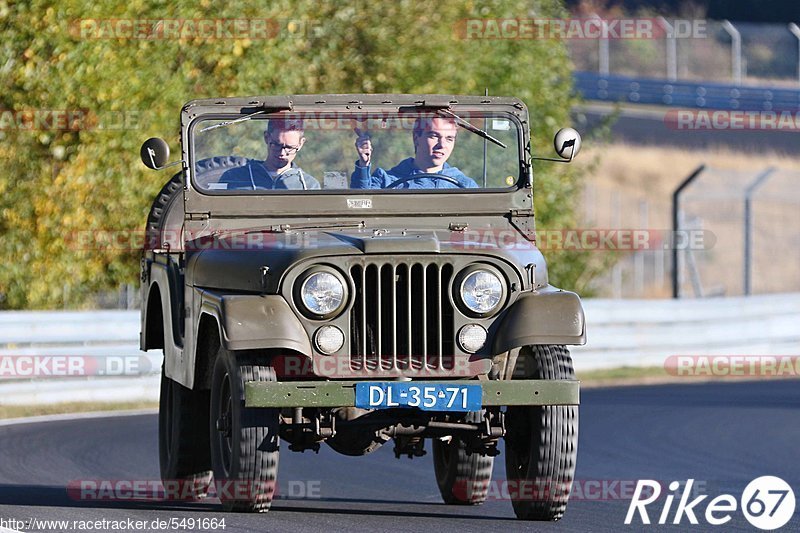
[573,71,800,111]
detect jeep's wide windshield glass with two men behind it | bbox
[189,110,524,195]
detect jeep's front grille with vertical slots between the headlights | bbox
[350,259,454,372]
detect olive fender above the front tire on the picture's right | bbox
[494,289,586,353]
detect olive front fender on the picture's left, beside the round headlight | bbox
[201,292,311,355]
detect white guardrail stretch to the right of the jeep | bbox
[572,293,800,372]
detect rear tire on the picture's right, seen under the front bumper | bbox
[433,413,494,505]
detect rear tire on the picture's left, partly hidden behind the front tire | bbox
[158,369,211,498]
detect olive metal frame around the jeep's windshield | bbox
[181,95,532,218]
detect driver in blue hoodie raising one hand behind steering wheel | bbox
[350,117,478,189]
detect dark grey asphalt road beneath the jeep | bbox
[0,380,800,532]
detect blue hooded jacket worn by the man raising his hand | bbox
[350,157,478,189]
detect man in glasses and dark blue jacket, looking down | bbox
[219,118,320,190]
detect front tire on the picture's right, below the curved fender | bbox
[505,345,578,521]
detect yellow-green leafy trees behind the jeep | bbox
[0,0,584,308]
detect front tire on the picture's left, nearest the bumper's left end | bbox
[209,346,280,512]
